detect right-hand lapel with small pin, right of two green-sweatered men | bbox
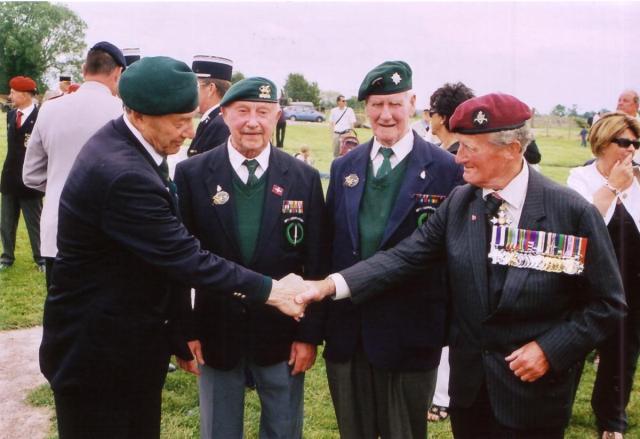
[380,136,432,248]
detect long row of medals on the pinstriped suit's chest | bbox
[489,224,588,275]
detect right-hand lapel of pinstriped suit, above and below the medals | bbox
[496,165,545,312]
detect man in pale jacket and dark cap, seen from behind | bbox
[21,41,125,285]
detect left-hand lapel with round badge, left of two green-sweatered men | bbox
[204,145,240,257]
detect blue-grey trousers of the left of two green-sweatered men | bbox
[198,361,304,439]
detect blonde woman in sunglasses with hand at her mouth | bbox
[567,112,640,439]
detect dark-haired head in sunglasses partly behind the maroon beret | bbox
[429,82,475,155]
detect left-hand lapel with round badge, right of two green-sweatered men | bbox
[344,138,373,248]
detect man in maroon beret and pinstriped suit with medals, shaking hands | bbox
[299,93,626,438]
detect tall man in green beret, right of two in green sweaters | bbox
[312,61,462,439]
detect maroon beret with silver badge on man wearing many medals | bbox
[449,93,531,134]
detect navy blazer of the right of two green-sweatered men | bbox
[324,135,463,371]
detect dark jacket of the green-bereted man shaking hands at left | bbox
[40,118,268,397]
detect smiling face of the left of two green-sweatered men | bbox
[221,101,280,158]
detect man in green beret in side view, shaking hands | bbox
[40,57,302,439]
